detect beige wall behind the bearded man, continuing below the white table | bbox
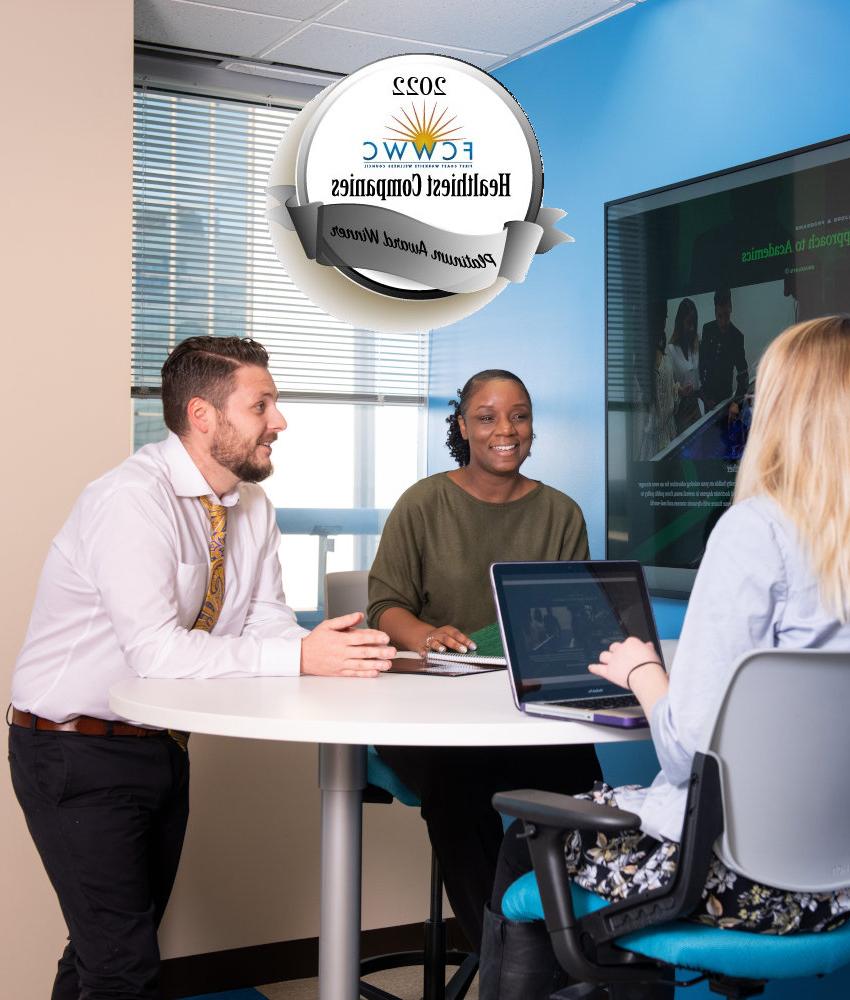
[0,0,428,1000]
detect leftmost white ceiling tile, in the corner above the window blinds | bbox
[135,0,298,56]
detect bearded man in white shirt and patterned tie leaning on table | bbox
[9,337,394,1000]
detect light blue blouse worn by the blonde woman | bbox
[616,497,850,841]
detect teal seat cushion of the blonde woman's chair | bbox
[502,872,850,979]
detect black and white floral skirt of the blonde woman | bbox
[564,782,850,934]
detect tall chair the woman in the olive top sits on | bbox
[325,570,478,1000]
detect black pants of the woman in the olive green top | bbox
[377,745,602,951]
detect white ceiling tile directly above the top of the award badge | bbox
[264,24,502,73]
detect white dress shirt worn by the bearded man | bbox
[12,434,307,722]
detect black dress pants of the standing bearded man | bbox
[9,726,189,1000]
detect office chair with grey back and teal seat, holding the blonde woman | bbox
[493,650,850,1000]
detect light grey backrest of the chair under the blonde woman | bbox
[708,649,850,892]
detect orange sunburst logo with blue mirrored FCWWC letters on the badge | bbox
[363,101,473,165]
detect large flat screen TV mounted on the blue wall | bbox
[605,136,850,596]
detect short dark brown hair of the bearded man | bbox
[157,337,269,434]
